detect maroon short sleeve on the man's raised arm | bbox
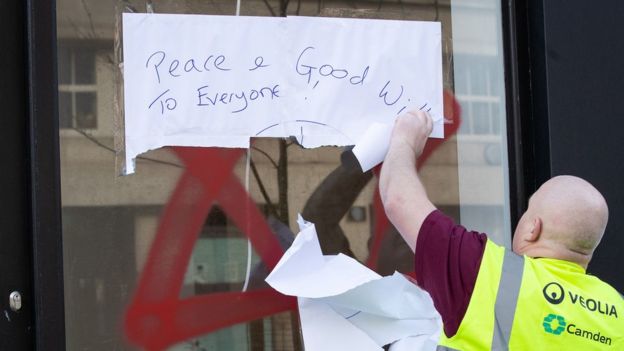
[415,210,487,337]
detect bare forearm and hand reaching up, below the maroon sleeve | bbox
[379,111,435,252]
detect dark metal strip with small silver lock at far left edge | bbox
[0,0,34,350]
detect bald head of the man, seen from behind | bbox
[513,176,609,267]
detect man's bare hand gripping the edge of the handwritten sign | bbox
[390,111,433,157]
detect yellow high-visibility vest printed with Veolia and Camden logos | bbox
[438,240,624,351]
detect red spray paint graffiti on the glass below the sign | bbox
[124,92,460,350]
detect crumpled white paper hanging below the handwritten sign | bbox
[266,217,442,351]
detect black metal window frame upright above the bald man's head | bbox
[501,0,550,233]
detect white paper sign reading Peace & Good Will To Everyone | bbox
[123,14,443,173]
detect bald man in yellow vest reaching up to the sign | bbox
[379,111,624,350]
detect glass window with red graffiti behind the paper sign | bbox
[57,0,510,351]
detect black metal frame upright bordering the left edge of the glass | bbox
[26,0,65,350]
